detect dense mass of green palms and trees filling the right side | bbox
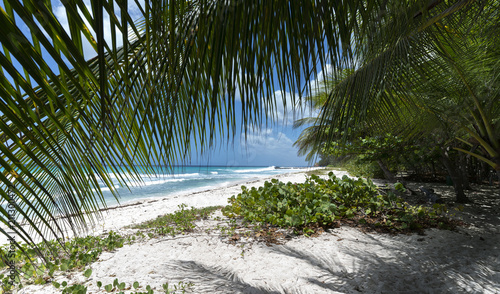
[296,1,500,202]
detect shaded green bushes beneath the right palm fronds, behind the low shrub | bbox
[320,133,446,181]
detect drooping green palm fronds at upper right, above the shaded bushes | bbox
[316,1,500,168]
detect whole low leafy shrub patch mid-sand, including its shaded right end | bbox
[223,172,458,232]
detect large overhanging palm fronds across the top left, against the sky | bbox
[0,0,494,254]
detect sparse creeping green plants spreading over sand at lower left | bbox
[0,204,220,293]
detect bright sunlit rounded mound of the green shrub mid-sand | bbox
[223,172,378,227]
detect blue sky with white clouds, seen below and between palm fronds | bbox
[4,1,332,166]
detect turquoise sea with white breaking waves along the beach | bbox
[98,166,306,206]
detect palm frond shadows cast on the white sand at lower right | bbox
[161,185,500,293]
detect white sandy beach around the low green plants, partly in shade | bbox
[13,172,500,293]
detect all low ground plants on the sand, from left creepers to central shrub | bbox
[0,172,458,294]
